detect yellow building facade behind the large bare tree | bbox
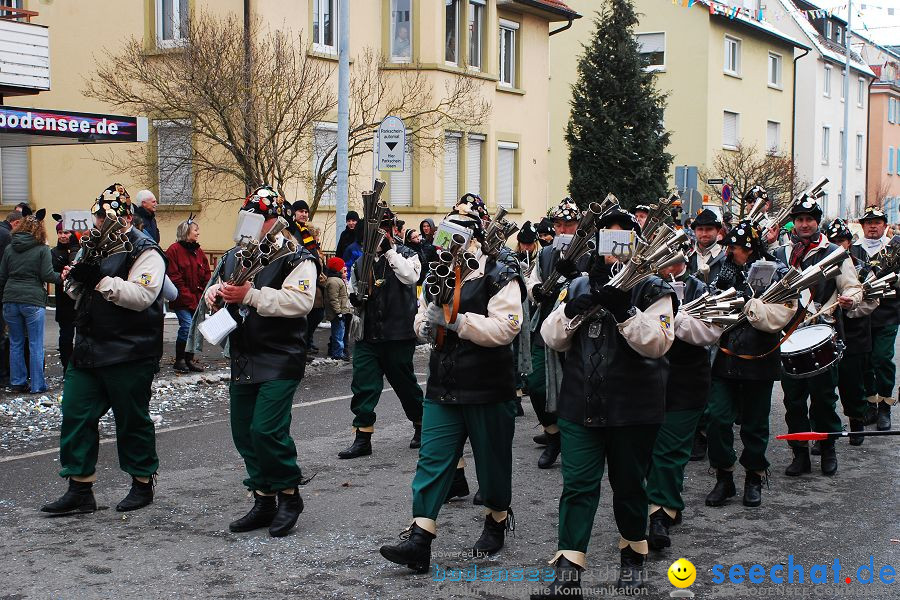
[4,0,578,250]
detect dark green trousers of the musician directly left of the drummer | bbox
[706,376,775,471]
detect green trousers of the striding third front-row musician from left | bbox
[412,399,516,519]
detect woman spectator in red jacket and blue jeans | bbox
[166,217,210,373]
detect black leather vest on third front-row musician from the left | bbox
[425,259,525,404]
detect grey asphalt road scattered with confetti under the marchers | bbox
[0,322,900,600]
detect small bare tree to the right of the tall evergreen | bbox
[700,141,807,218]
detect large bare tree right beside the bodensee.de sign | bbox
[84,13,336,202]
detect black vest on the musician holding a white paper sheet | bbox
[222,247,318,384]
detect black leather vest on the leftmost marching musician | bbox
[72,228,166,369]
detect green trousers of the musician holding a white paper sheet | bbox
[229,379,302,494]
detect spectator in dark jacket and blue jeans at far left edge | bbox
[0,211,60,394]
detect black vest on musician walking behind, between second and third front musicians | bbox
[353,244,417,342]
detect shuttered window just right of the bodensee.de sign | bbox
[154,121,194,204]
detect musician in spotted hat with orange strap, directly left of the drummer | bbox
[706,220,797,506]
